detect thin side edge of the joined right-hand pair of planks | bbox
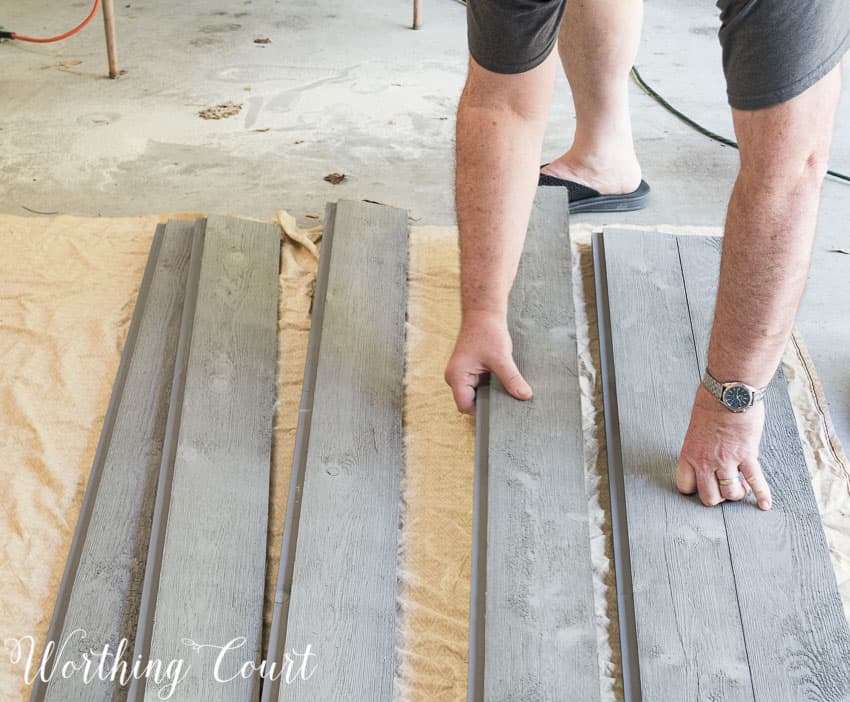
[593,232,641,702]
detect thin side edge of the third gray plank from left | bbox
[253,202,336,702]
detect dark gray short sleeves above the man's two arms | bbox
[467,0,850,110]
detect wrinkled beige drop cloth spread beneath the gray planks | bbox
[0,216,850,702]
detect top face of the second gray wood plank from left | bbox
[144,217,280,702]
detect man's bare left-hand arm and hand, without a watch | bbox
[446,52,557,412]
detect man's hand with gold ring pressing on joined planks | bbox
[676,386,771,510]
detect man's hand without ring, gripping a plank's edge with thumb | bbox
[445,312,531,414]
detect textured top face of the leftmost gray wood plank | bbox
[32,222,193,702]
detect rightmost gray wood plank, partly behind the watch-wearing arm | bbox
[677,236,850,702]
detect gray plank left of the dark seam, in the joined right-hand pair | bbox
[603,229,753,702]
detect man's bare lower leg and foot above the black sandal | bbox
[543,0,643,194]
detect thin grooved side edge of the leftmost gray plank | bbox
[30,224,165,702]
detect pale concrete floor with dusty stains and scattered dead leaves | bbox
[0,0,850,446]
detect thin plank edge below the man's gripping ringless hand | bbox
[466,374,490,702]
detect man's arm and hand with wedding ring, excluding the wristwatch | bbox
[676,69,840,509]
